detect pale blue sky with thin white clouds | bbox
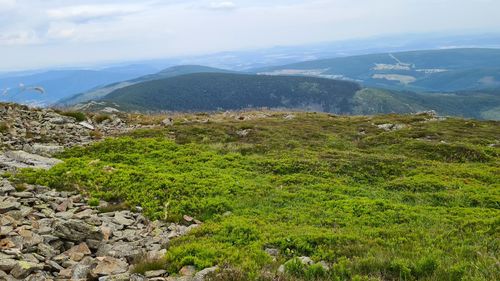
[0,0,500,70]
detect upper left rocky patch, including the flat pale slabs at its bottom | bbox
[0,103,144,171]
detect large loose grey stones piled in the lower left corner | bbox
[0,179,203,281]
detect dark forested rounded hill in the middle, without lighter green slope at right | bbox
[103,73,360,113]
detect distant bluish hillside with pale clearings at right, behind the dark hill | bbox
[255,49,500,92]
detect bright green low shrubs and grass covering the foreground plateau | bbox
[17,113,500,280]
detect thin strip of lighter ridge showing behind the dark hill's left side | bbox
[58,65,238,106]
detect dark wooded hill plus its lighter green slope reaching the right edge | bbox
[79,73,500,120]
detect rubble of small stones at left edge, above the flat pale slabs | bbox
[0,103,143,153]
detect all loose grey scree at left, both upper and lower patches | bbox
[0,104,215,281]
